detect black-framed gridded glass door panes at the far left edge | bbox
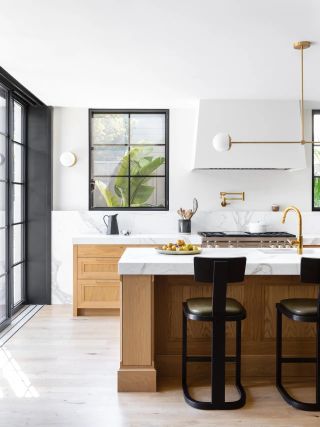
[0,85,26,329]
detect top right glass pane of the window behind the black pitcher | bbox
[130,114,165,144]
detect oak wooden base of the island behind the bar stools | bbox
[118,275,317,391]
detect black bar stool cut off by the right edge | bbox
[276,258,320,411]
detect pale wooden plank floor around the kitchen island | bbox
[0,305,320,427]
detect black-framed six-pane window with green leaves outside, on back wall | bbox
[89,109,169,210]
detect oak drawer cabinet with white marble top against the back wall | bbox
[73,234,201,316]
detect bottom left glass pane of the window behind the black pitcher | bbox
[93,177,129,208]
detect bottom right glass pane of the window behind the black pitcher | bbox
[130,177,166,208]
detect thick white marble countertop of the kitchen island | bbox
[119,248,320,275]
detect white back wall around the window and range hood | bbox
[53,103,311,214]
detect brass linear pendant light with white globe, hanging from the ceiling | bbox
[212,41,313,152]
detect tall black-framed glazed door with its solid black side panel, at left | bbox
[0,67,52,330]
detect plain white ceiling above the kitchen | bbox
[0,0,320,108]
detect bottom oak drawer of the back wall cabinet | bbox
[78,280,120,308]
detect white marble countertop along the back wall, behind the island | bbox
[72,233,201,245]
